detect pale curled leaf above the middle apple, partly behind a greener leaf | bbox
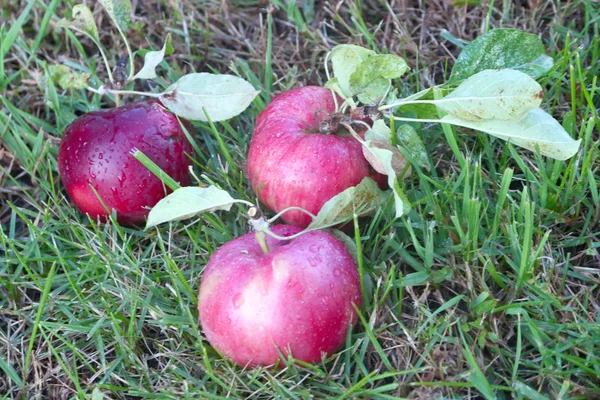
[328,44,377,99]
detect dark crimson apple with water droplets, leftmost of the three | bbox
[58,99,192,224]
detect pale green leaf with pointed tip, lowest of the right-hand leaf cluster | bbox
[442,108,581,160]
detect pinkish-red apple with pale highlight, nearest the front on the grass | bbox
[198,225,361,366]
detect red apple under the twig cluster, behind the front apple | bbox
[247,86,387,227]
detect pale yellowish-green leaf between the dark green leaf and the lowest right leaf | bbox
[435,69,544,121]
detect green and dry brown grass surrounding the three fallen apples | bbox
[0,0,600,400]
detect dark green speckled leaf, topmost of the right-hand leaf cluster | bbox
[450,29,552,82]
